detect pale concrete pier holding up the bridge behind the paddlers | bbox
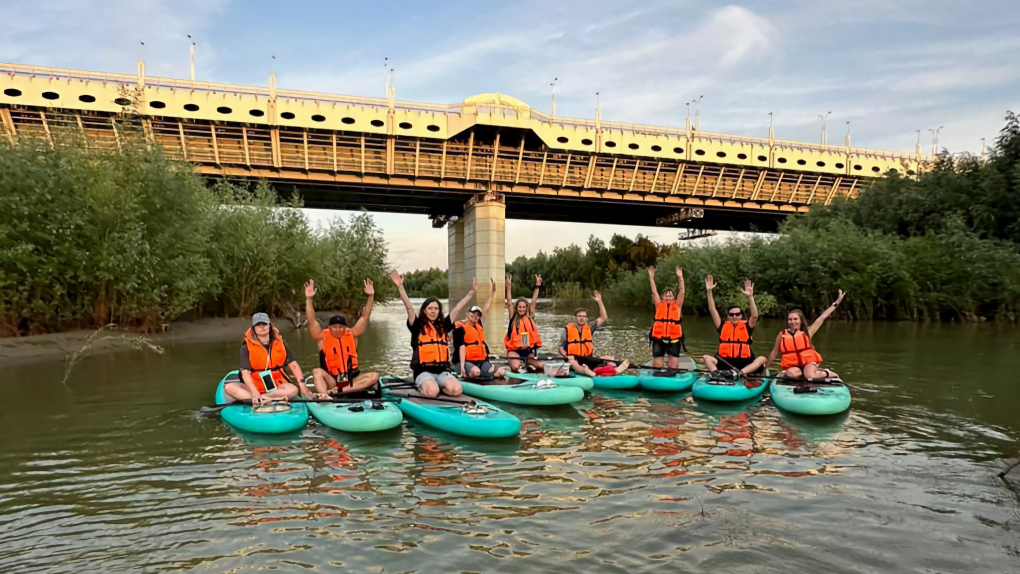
[448,192,507,322]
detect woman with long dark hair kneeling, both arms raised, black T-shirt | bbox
[390,271,477,398]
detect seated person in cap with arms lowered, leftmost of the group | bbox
[223,313,313,405]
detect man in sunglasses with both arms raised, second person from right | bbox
[703,275,768,376]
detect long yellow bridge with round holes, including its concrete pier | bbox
[0,62,924,305]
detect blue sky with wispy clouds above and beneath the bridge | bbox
[0,0,1020,270]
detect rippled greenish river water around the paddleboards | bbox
[0,304,1020,574]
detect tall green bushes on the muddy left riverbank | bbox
[0,138,393,336]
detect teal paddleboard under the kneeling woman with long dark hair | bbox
[380,377,520,438]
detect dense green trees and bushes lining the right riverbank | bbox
[405,112,1020,321]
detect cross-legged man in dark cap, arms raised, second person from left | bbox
[305,279,381,399]
